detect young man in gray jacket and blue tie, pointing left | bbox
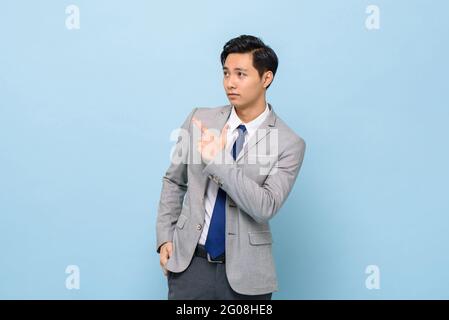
[157,35,305,300]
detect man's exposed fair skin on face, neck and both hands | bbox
[159,52,274,275]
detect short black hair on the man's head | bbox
[220,35,278,89]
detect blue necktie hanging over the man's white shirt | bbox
[205,124,246,259]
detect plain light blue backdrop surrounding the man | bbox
[0,0,449,299]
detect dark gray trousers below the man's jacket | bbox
[167,256,272,300]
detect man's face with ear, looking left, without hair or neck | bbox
[223,53,271,108]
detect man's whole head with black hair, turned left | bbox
[220,35,278,107]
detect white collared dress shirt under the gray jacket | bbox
[199,103,270,245]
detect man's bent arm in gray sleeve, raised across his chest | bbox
[203,138,306,223]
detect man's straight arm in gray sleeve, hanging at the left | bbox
[156,108,197,253]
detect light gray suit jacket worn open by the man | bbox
[156,104,305,295]
